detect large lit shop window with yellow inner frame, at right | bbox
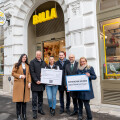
[100,18,120,80]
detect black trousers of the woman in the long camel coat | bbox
[16,102,26,115]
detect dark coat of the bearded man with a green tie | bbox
[65,61,78,98]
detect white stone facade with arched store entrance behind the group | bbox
[0,0,105,105]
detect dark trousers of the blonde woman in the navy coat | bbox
[78,99,92,120]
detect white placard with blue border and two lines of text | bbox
[66,75,90,91]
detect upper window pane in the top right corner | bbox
[100,0,120,10]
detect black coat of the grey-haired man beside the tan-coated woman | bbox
[30,58,46,91]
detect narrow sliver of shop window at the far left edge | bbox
[0,46,4,75]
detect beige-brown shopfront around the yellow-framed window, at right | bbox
[97,0,120,105]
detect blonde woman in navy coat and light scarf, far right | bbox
[77,57,96,120]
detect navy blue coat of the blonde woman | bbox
[77,67,97,100]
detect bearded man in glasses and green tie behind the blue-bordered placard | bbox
[65,54,78,116]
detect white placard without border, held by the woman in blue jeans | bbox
[41,68,62,85]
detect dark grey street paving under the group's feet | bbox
[0,95,120,120]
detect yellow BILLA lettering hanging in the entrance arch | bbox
[33,8,58,25]
